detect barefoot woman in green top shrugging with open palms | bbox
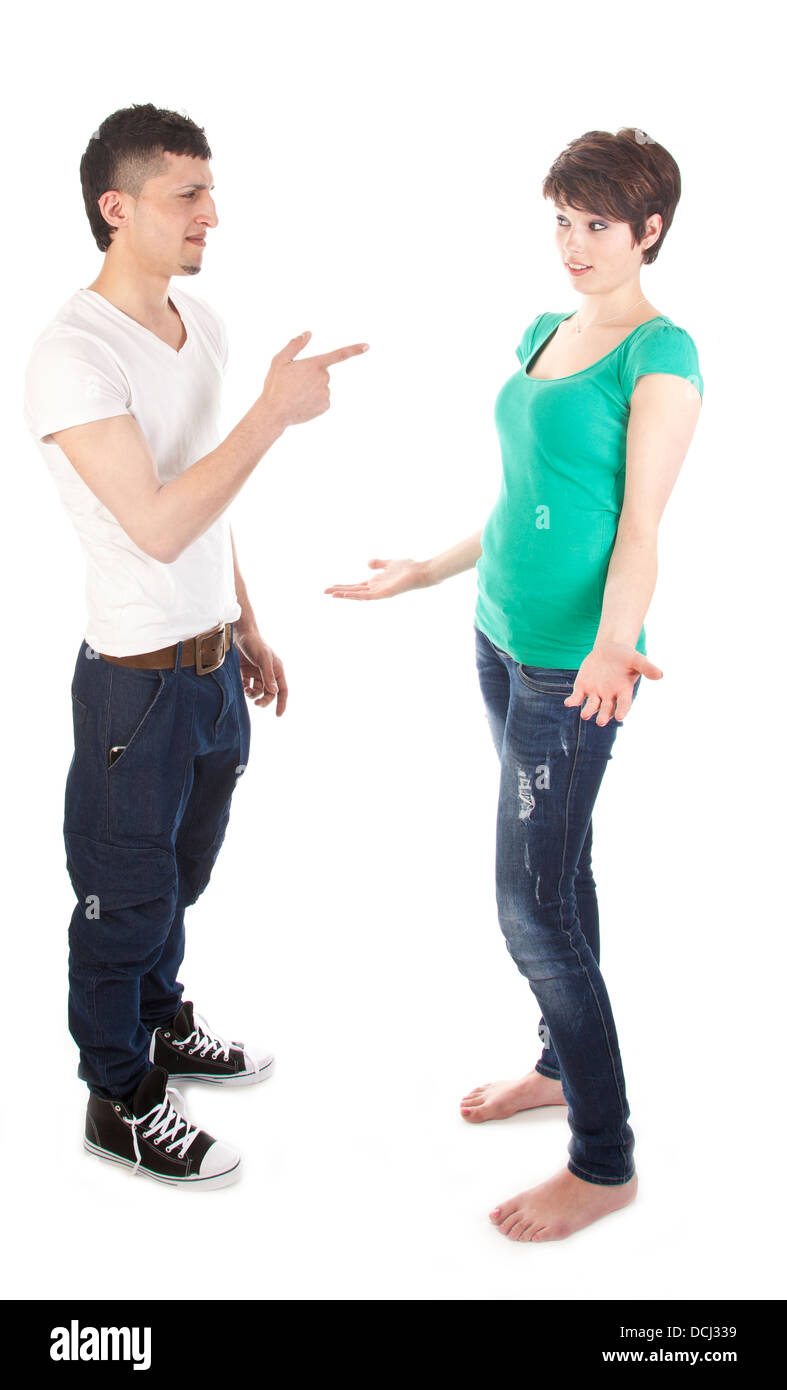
[325,128,702,1241]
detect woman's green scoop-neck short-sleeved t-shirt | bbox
[476,313,702,669]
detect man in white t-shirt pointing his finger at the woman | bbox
[25,104,367,1188]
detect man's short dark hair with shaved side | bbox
[79,101,211,252]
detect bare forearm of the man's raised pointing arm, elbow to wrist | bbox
[152,400,285,561]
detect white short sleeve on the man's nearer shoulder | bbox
[25,334,131,443]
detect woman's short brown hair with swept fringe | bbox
[542,126,680,265]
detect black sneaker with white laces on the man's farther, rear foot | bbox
[149,999,274,1086]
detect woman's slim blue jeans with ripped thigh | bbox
[476,628,641,1184]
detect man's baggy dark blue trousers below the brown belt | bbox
[63,631,250,1097]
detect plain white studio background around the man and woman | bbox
[1,0,787,1300]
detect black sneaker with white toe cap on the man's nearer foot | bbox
[85,1066,241,1187]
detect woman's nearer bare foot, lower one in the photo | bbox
[489,1168,637,1240]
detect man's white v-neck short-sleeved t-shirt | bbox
[25,289,241,656]
